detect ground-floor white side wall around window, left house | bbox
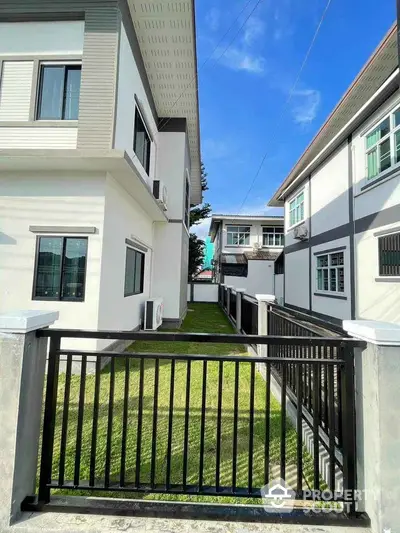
[98,176,153,348]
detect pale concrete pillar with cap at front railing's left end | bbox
[0,311,58,531]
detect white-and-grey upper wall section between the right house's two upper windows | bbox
[310,142,349,236]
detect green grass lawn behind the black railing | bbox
[53,304,312,503]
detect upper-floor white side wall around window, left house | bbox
[114,20,158,188]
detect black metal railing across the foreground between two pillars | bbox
[32,329,362,511]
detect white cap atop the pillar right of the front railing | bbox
[343,320,400,346]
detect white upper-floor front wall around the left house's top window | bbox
[0,21,84,150]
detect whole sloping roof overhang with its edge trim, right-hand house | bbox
[268,24,399,207]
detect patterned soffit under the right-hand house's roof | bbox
[270,25,398,205]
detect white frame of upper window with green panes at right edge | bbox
[363,103,400,185]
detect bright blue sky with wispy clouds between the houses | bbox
[196,0,396,237]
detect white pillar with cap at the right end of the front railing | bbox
[343,320,400,533]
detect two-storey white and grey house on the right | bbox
[269,26,400,324]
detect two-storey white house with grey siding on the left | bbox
[0,0,202,346]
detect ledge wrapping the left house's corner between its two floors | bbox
[0,149,168,222]
